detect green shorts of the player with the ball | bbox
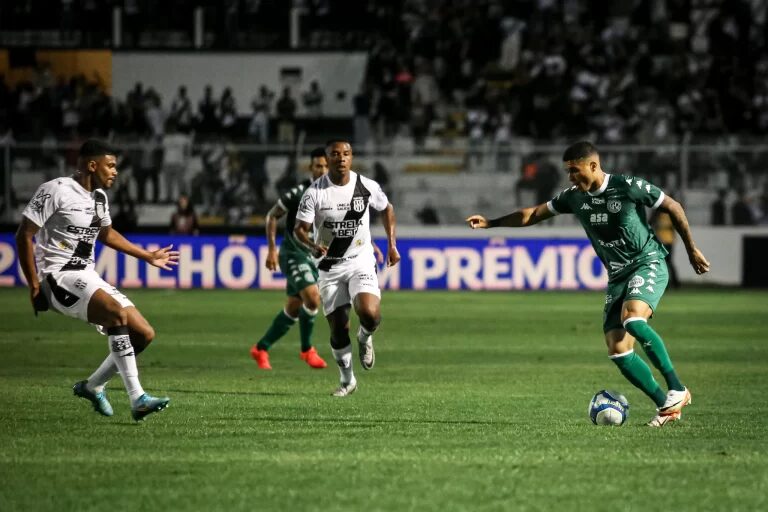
[603,259,669,332]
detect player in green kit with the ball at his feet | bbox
[467,142,709,427]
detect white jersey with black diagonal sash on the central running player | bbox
[296,171,389,270]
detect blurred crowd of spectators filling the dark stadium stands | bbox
[0,0,768,226]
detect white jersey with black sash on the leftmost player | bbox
[22,178,112,273]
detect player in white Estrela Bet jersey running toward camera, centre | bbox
[294,140,400,397]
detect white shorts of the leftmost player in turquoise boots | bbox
[40,270,133,322]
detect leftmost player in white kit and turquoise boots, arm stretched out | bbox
[16,140,179,421]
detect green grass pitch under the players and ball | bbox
[0,289,768,511]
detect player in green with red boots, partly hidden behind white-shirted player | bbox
[251,148,328,370]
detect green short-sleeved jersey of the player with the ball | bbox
[547,173,667,279]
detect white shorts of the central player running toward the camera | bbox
[319,257,381,316]
